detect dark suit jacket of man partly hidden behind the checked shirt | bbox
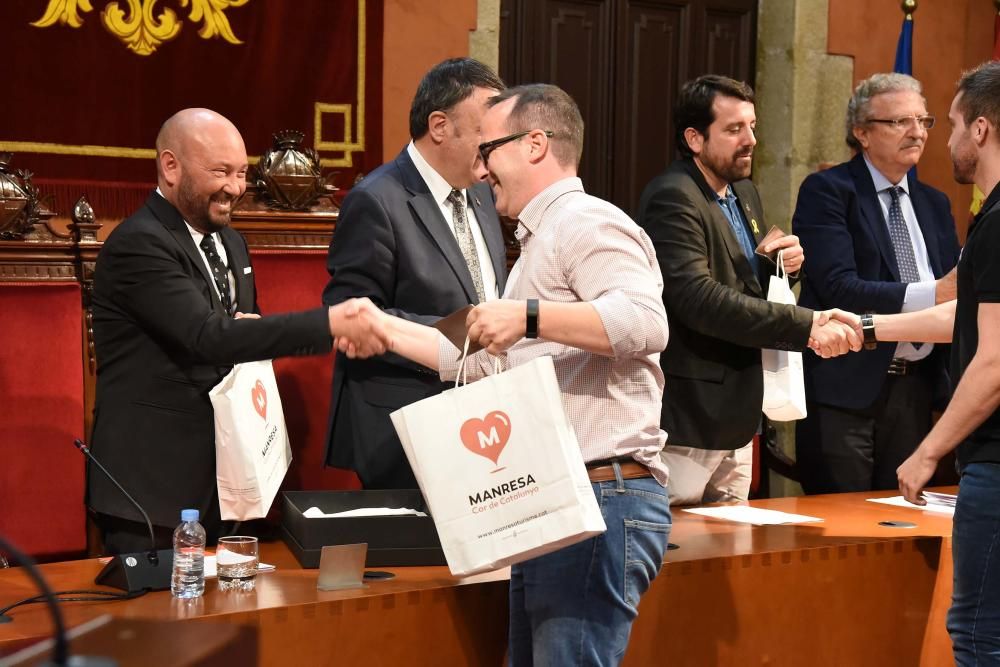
[323,149,507,488]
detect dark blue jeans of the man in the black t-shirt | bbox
[948,463,1000,667]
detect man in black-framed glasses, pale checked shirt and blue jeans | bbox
[383,84,670,666]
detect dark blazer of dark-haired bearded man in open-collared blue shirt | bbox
[639,159,812,449]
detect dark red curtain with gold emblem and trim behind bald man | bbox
[0,0,382,216]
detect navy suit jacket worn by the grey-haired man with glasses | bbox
[792,153,958,409]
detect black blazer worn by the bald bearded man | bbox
[87,193,331,526]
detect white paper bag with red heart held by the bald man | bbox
[208,361,292,521]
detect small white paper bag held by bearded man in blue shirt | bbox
[761,250,806,421]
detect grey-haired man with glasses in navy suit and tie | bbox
[792,74,958,493]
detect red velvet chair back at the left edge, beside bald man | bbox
[0,281,86,560]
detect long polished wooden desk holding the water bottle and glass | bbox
[0,493,951,667]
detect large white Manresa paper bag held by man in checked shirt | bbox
[391,357,606,575]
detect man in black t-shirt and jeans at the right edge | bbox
[862,62,1000,667]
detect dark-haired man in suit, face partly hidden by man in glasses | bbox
[323,58,506,489]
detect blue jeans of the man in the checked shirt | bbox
[509,464,670,667]
